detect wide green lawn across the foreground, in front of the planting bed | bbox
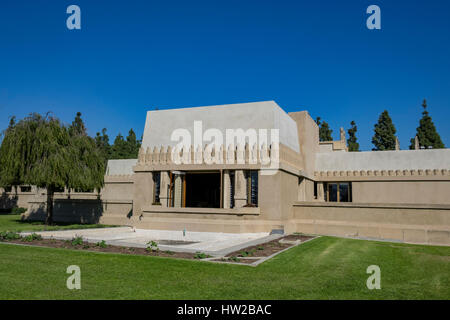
[0,237,450,299]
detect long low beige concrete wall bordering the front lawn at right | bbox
[287,202,450,245]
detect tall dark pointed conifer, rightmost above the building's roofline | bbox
[409,99,445,149]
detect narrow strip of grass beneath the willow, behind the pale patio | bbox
[0,214,116,232]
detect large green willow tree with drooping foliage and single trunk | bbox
[0,113,105,224]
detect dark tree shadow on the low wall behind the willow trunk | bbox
[24,199,103,224]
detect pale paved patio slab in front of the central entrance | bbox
[23,227,282,256]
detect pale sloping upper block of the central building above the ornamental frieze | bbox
[142,101,300,152]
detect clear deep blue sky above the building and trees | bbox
[0,0,450,150]
